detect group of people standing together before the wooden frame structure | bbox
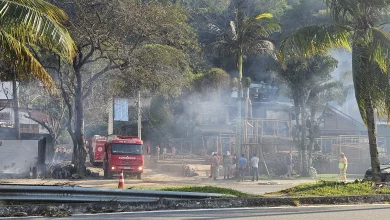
[210,151,260,182]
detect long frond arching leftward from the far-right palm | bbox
[278,25,353,64]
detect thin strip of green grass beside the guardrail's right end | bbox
[158,186,262,198]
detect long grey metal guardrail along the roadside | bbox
[0,185,226,203]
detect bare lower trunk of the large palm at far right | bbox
[366,97,381,183]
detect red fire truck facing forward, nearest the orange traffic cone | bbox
[103,135,144,179]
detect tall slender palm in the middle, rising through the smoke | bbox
[225,0,280,155]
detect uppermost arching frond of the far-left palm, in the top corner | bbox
[0,0,76,60]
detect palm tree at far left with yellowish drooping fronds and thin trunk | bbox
[0,0,75,138]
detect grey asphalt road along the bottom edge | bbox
[20,205,390,220]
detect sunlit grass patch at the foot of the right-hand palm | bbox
[267,181,390,197]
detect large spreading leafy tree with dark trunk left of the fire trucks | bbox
[48,0,196,173]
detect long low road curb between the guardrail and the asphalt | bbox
[0,194,390,217]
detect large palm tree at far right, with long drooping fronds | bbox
[279,0,390,182]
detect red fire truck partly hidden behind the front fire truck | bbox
[87,135,106,166]
